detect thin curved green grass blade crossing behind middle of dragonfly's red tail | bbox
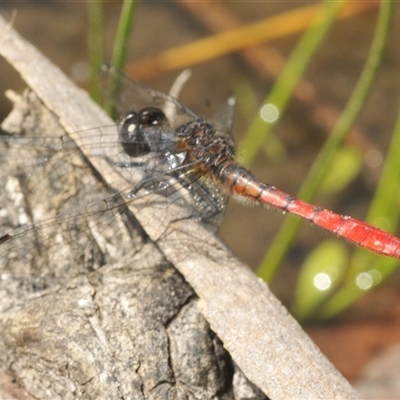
[257,1,393,281]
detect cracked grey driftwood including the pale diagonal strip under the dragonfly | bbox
[0,14,359,399]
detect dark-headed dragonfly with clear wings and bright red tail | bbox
[0,65,400,272]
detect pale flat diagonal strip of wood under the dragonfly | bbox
[0,17,360,400]
